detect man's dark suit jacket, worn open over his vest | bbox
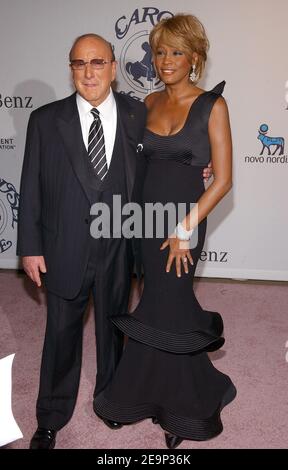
[17,93,146,298]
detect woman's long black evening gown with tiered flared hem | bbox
[94,82,236,440]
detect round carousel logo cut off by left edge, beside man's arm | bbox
[0,178,19,254]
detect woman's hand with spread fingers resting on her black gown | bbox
[160,235,193,277]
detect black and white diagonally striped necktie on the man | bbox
[88,108,108,180]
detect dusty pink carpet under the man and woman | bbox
[0,271,288,450]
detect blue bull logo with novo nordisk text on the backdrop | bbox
[245,124,288,163]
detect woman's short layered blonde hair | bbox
[149,13,209,80]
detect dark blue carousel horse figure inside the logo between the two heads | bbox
[126,41,160,88]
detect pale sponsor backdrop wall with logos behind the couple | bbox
[0,0,288,281]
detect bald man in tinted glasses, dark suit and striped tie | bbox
[17,34,146,449]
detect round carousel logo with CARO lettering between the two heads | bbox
[115,7,173,96]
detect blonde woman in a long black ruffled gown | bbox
[94,15,236,448]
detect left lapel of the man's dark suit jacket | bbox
[56,93,96,204]
